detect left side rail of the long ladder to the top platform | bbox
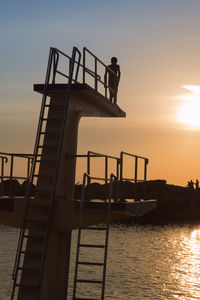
[11,48,53,300]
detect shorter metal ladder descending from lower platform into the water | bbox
[72,173,116,300]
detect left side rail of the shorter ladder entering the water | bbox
[72,173,90,300]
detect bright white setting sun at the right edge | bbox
[178,85,200,129]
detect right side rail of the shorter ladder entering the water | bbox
[101,174,117,300]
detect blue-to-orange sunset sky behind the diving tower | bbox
[0,0,200,186]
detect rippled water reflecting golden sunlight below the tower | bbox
[0,225,200,300]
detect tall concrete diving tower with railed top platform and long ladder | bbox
[0,47,156,300]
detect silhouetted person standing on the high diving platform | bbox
[104,57,121,104]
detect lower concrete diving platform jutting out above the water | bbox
[0,197,157,227]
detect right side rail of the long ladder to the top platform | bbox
[39,47,81,279]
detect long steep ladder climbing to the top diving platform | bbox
[11,47,81,300]
